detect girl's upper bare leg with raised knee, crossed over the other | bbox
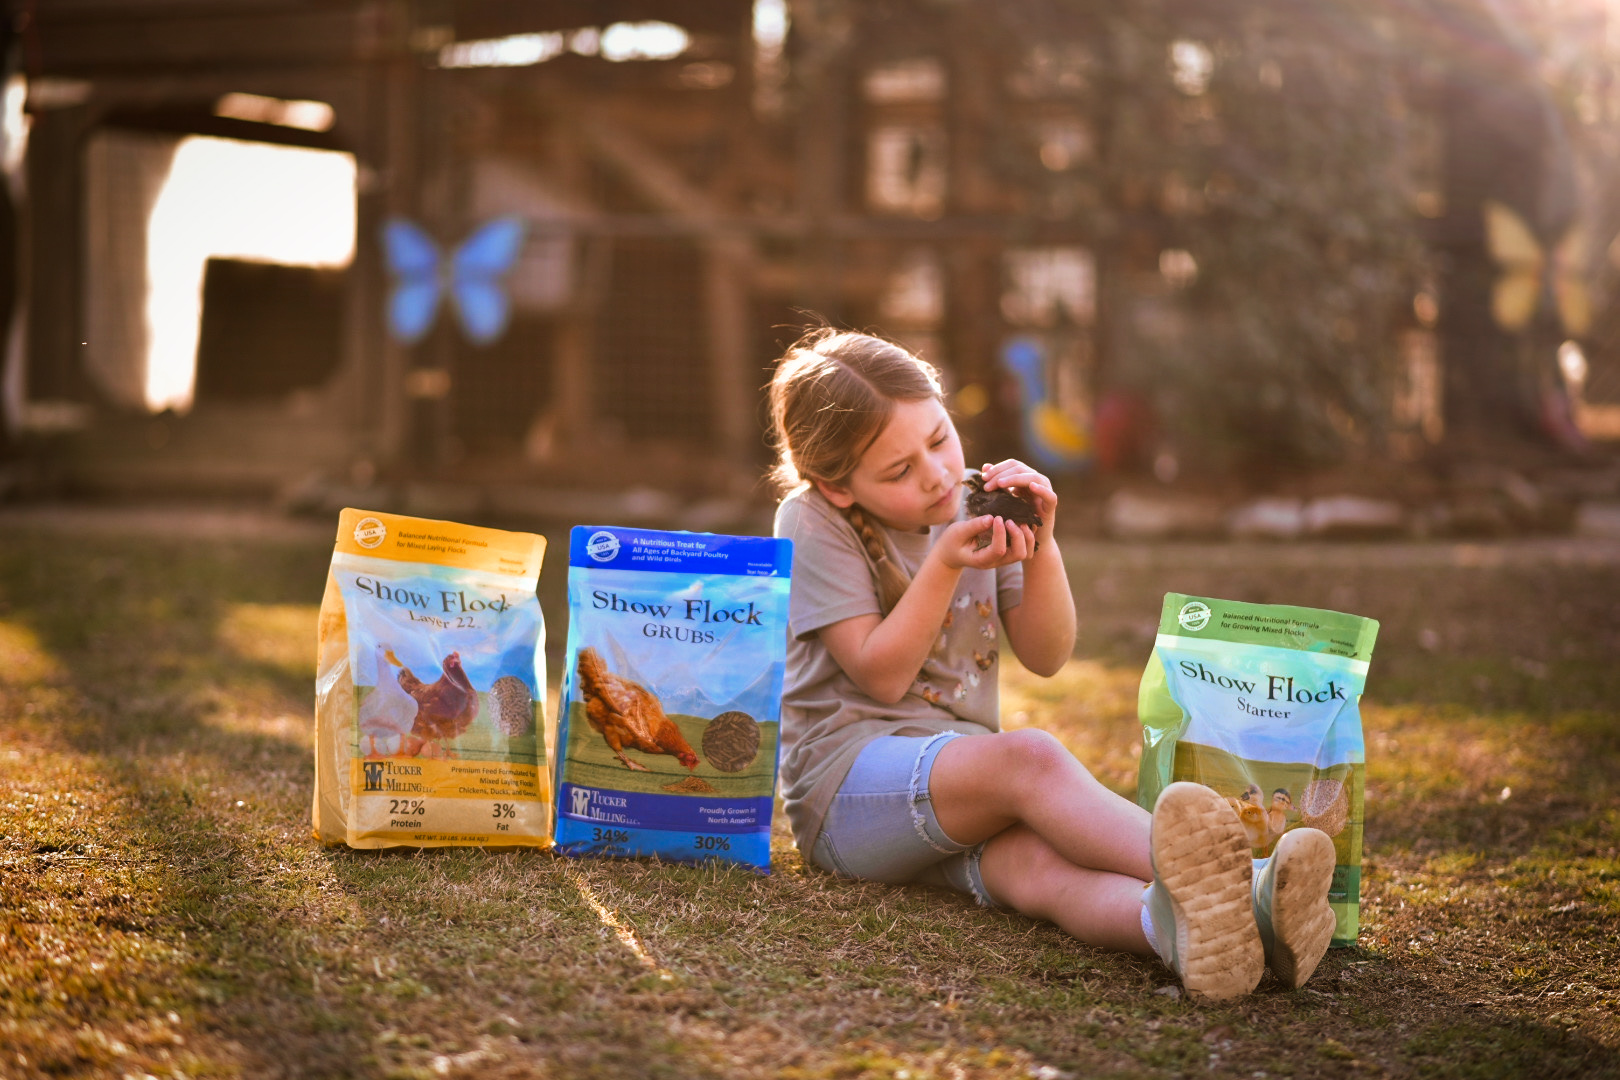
[928,729,1153,880]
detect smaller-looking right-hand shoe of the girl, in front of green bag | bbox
[1254,829,1338,989]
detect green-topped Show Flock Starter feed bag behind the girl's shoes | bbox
[1137,593,1379,946]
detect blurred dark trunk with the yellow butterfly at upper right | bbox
[1432,0,1581,458]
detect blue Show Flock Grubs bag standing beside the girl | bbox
[556,526,792,873]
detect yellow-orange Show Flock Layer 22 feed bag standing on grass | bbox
[314,510,551,847]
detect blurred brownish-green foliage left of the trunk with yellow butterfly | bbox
[996,0,1427,465]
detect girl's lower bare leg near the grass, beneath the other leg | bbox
[954,822,1153,957]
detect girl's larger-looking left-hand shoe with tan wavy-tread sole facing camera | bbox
[1145,780,1263,1001]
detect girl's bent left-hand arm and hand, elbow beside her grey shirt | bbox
[820,517,1030,704]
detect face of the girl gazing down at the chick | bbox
[816,398,962,529]
